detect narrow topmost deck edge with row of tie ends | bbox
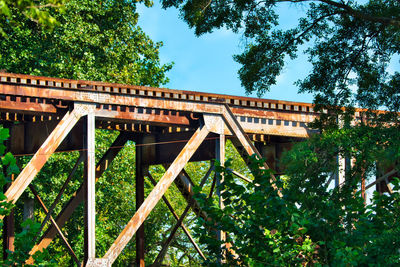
[0,73,318,116]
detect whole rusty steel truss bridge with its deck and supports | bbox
[0,73,394,266]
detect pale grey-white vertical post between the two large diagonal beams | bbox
[84,112,96,264]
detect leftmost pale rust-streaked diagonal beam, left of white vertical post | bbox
[0,108,84,219]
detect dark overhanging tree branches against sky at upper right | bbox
[162,0,400,111]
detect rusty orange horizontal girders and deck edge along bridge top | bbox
[0,72,319,137]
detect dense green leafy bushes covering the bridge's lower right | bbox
[193,126,400,266]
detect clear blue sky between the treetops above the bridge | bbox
[138,1,312,102]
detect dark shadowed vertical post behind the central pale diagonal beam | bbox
[135,137,144,267]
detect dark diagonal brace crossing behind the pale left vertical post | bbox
[30,132,128,254]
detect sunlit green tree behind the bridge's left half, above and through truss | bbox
[0,0,175,265]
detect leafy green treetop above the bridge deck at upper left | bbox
[0,0,172,86]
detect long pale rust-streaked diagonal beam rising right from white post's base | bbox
[104,127,209,264]
